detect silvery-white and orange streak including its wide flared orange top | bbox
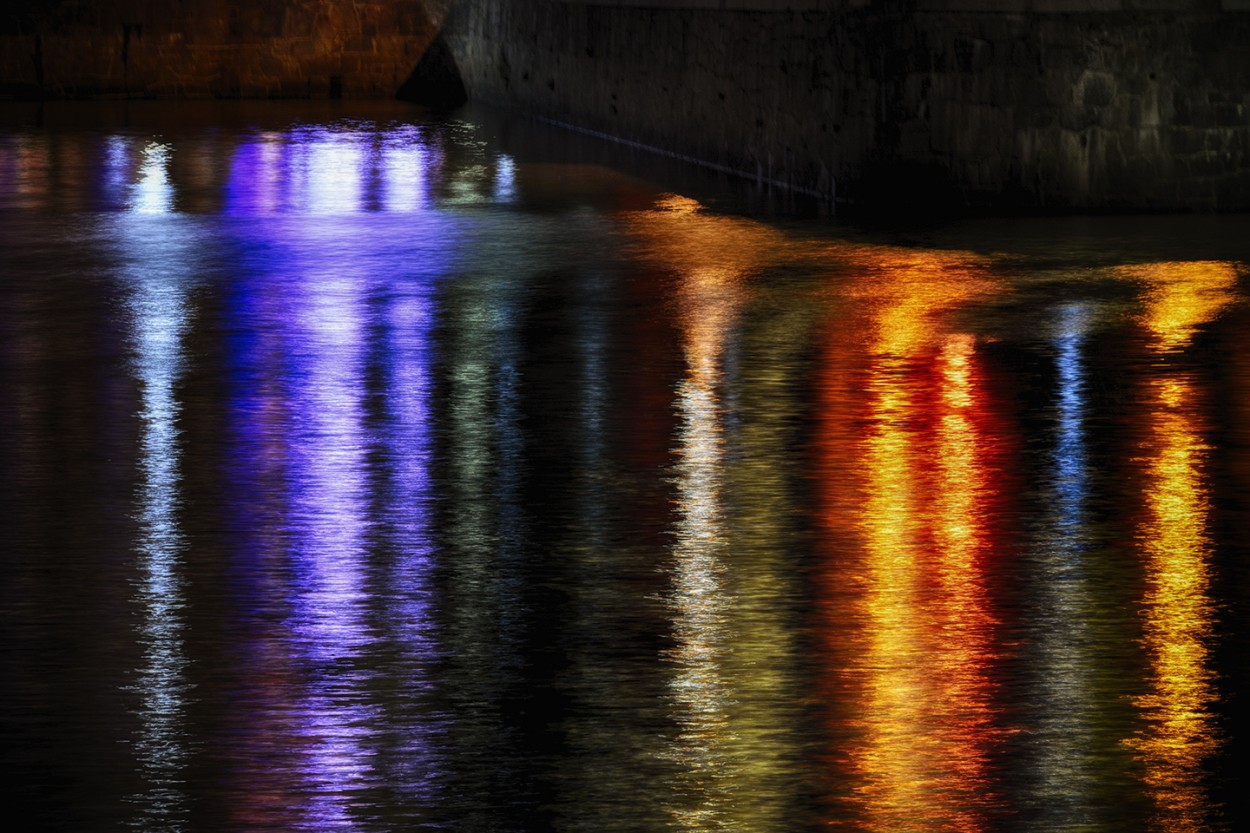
[631,192,754,830]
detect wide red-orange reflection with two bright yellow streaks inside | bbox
[823,243,1004,830]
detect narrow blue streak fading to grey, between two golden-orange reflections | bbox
[1024,300,1130,832]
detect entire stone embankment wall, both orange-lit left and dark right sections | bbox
[9,0,1250,211]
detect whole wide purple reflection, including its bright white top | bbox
[217,118,459,830]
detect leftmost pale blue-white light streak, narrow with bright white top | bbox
[121,143,195,830]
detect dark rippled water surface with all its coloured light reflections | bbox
[0,105,1250,833]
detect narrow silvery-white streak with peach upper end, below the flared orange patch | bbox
[668,261,743,830]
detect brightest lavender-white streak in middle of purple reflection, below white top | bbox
[288,255,378,833]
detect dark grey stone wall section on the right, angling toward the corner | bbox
[446,0,1250,211]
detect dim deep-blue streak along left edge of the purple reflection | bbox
[215,268,304,830]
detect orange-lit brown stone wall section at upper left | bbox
[0,0,435,98]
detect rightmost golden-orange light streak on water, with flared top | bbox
[1121,257,1238,833]
